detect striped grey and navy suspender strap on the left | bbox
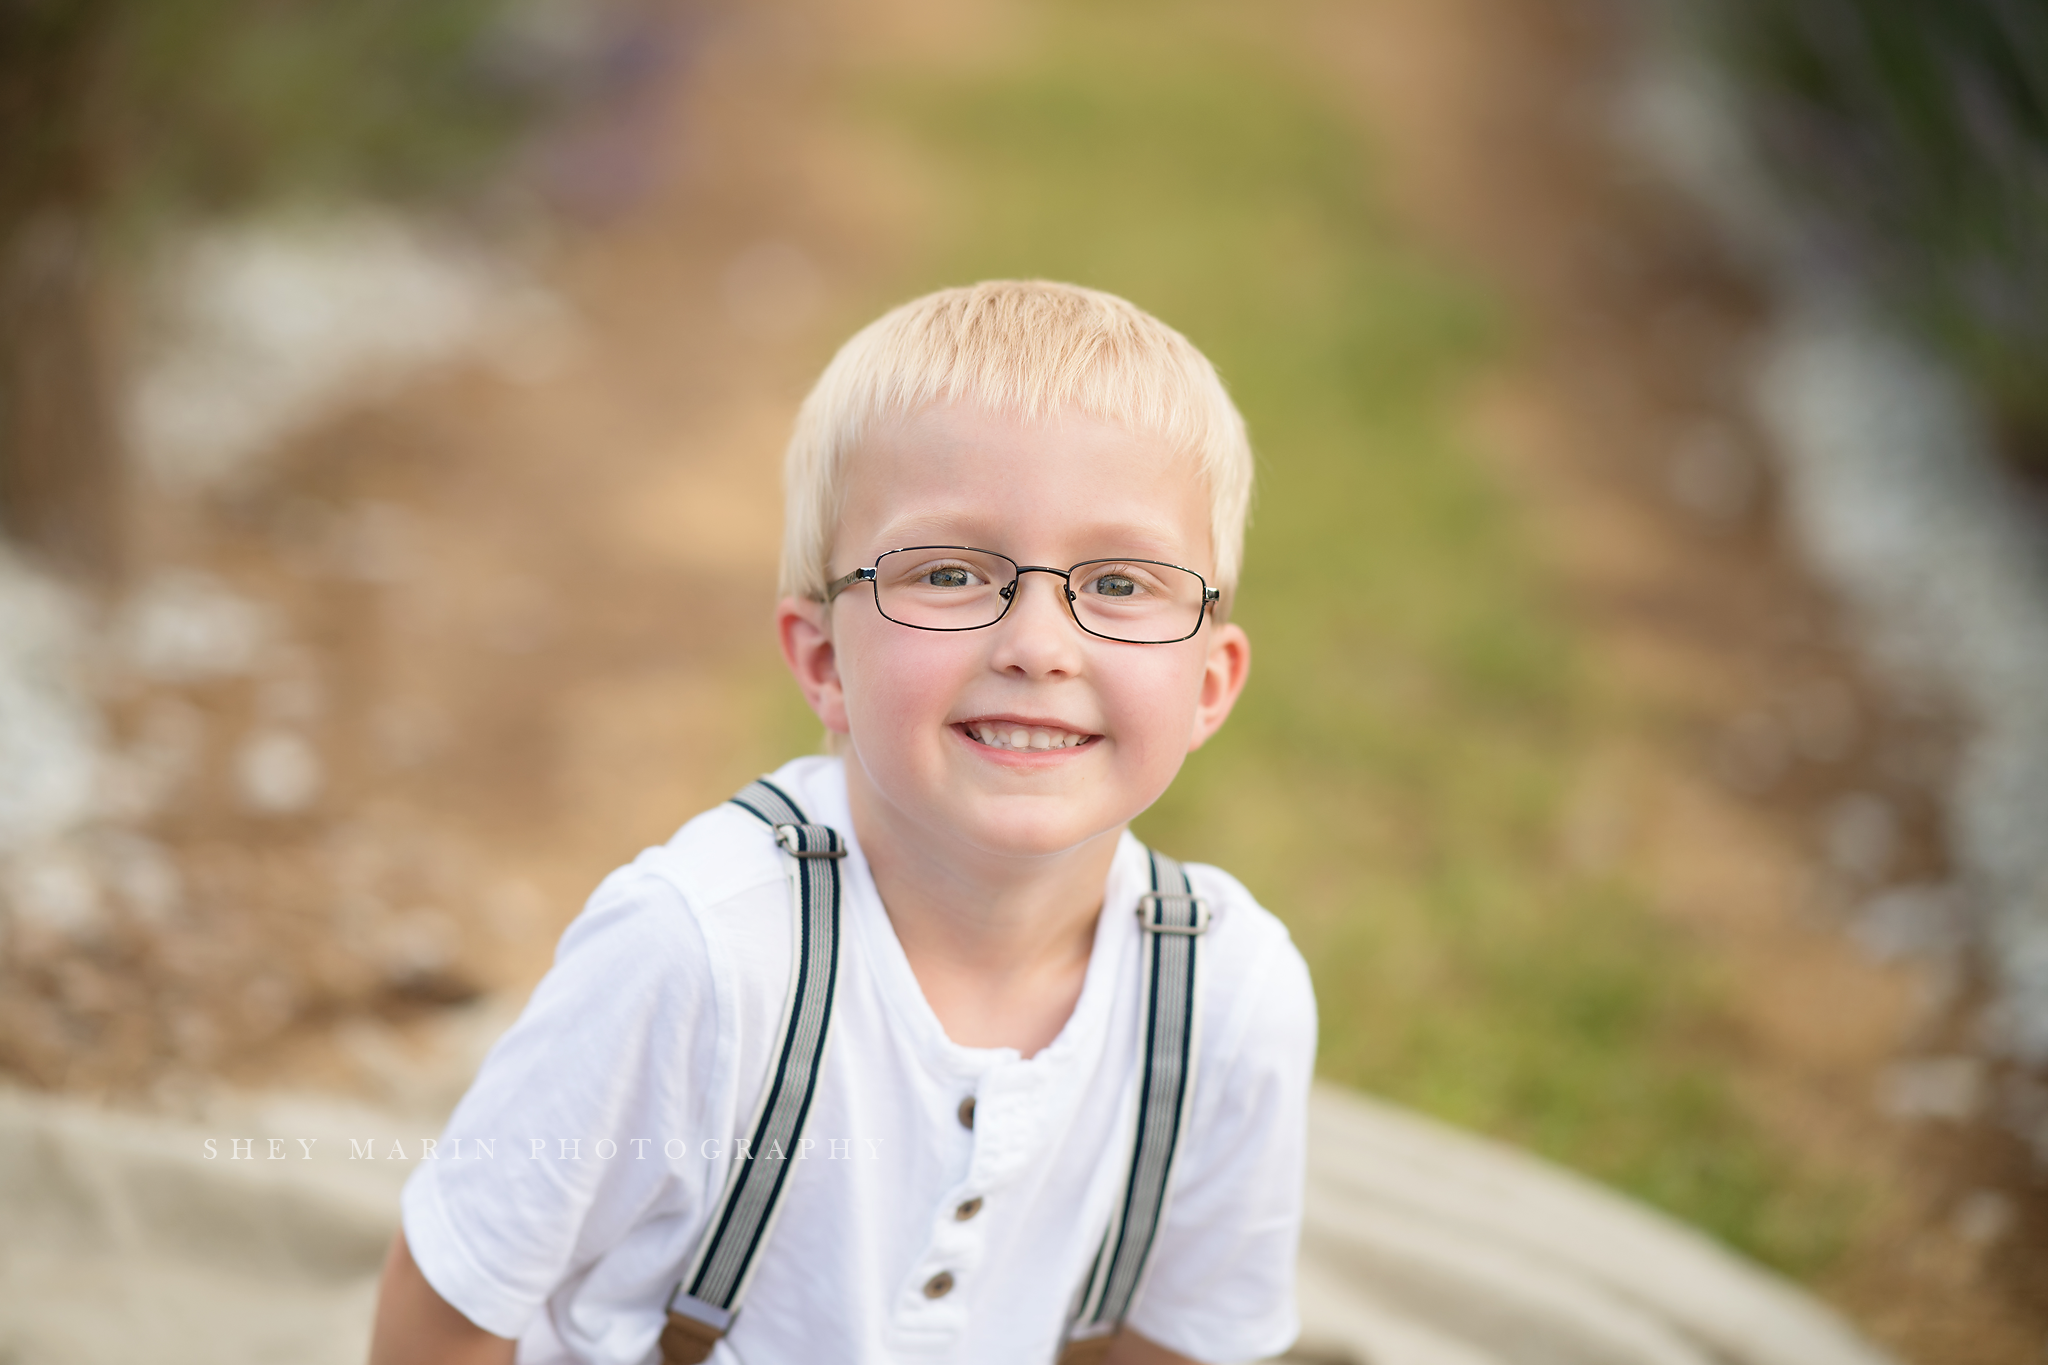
[662,778,846,1365]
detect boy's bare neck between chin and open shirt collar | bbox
[846,757,1122,1056]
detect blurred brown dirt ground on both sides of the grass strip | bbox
[0,0,2048,1365]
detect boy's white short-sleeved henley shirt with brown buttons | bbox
[403,757,1315,1365]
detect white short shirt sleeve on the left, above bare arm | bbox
[401,868,719,1336]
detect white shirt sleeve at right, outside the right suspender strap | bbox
[1128,896,1317,1365]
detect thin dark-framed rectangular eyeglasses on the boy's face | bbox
[825,544,1223,645]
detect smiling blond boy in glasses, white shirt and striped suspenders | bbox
[371,280,1315,1365]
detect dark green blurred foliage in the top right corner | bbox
[1722,0,2048,458]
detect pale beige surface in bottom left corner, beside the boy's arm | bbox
[0,1093,403,1365]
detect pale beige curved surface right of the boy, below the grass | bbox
[1294,1087,1888,1365]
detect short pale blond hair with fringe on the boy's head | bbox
[782,280,1251,606]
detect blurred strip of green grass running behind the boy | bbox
[858,4,1847,1273]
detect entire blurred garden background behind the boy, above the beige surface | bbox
[0,0,2048,1363]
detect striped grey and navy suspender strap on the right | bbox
[1061,853,1208,1361]
